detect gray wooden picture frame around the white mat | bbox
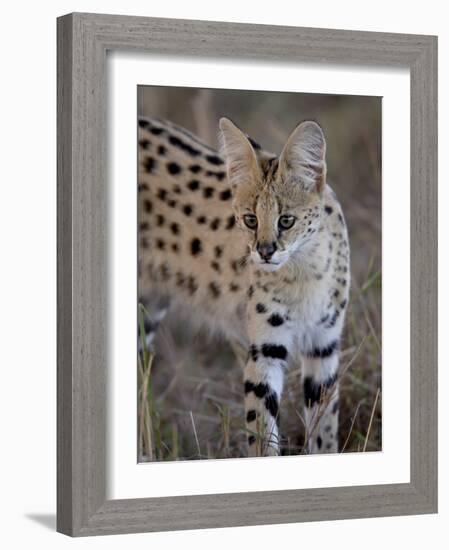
[57,13,437,536]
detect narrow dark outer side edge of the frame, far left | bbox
[57,17,73,533]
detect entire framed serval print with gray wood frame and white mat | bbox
[58,14,437,536]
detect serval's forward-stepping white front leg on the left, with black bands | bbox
[244,300,291,457]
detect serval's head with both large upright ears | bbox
[220,118,326,271]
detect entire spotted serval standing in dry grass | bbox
[138,118,350,456]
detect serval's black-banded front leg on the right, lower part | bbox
[302,340,339,454]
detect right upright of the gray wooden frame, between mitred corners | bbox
[410,35,438,510]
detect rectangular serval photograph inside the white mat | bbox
[136,85,382,463]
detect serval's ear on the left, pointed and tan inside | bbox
[220,118,260,185]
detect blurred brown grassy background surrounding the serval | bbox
[138,86,382,461]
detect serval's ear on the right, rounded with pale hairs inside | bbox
[279,120,326,193]
